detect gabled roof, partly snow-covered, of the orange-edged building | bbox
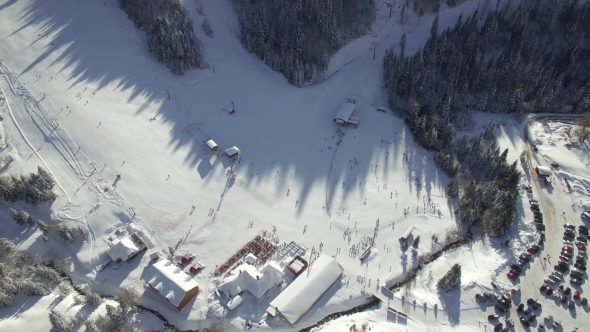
[144,259,199,307]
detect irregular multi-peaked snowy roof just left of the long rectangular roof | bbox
[217,262,285,298]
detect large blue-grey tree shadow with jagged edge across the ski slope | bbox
[7,0,454,222]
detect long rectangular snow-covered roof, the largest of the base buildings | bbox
[270,254,344,324]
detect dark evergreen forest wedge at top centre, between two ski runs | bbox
[232,0,375,86]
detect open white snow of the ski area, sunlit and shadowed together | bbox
[0,0,587,331]
